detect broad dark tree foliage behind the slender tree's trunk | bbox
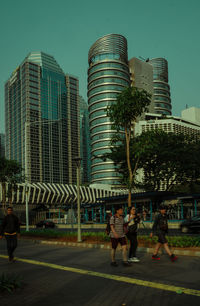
[103,130,200,192]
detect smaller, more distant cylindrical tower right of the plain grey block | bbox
[149,58,172,115]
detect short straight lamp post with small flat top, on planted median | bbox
[72,156,82,242]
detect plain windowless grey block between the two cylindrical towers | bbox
[129,57,154,119]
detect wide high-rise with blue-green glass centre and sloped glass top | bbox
[5,52,80,183]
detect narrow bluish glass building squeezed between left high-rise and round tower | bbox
[79,96,91,184]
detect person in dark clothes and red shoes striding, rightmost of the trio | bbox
[150,205,177,261]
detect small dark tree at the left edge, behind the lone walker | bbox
[0,157,22,212]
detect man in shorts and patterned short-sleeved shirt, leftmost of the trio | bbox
[110,207,131,267]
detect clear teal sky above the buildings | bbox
[0,0,200,133]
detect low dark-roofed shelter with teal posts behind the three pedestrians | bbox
[82,191,200,223]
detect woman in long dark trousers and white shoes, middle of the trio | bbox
[124,206,140,262]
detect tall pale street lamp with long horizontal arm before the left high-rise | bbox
[24,119,61,232]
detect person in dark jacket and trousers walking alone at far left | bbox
[0,207,20,262]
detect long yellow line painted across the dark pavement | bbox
[0,255,200,296]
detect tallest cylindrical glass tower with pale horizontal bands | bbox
[88,34,130,185]
